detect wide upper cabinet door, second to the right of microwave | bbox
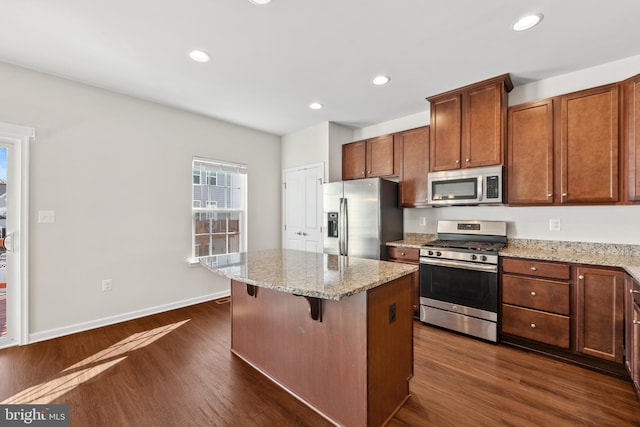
[560,84,620,203]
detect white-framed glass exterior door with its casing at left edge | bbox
[0,123,34,348]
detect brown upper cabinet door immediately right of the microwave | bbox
[506,99,554,205]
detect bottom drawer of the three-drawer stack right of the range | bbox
[502,304,570,348]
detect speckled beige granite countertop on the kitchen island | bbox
[200,249,418,301]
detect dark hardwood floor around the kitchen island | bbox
[0,302,640,427]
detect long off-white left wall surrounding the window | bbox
[0,64,281,339]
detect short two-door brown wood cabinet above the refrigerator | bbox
[342,135,396,180]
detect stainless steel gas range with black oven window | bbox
[420,221,507,342]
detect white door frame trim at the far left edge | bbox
[0,122,35,348]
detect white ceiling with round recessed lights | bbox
[0,0,640,135]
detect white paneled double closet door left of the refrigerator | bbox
[282,164,324,253]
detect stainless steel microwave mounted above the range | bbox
[427,166,502,206]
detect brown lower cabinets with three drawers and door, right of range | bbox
[500,258,624,373]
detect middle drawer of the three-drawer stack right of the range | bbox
[502,274,570,316]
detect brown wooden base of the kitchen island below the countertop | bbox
[231,276,413,427]
